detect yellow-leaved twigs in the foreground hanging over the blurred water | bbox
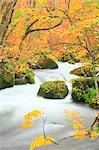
[21,109,99,150]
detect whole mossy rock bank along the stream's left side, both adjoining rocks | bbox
[0,63,35,90]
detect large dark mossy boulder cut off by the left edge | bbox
[0,63,14,90]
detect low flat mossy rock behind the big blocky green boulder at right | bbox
[70,65,97,77]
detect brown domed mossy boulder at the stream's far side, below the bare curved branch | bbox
[29,54,58,69]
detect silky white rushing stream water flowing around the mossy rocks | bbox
[0,63,99,150]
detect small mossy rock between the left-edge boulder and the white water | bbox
[15,69,35,85]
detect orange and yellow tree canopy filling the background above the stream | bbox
[0,0,99,71]
